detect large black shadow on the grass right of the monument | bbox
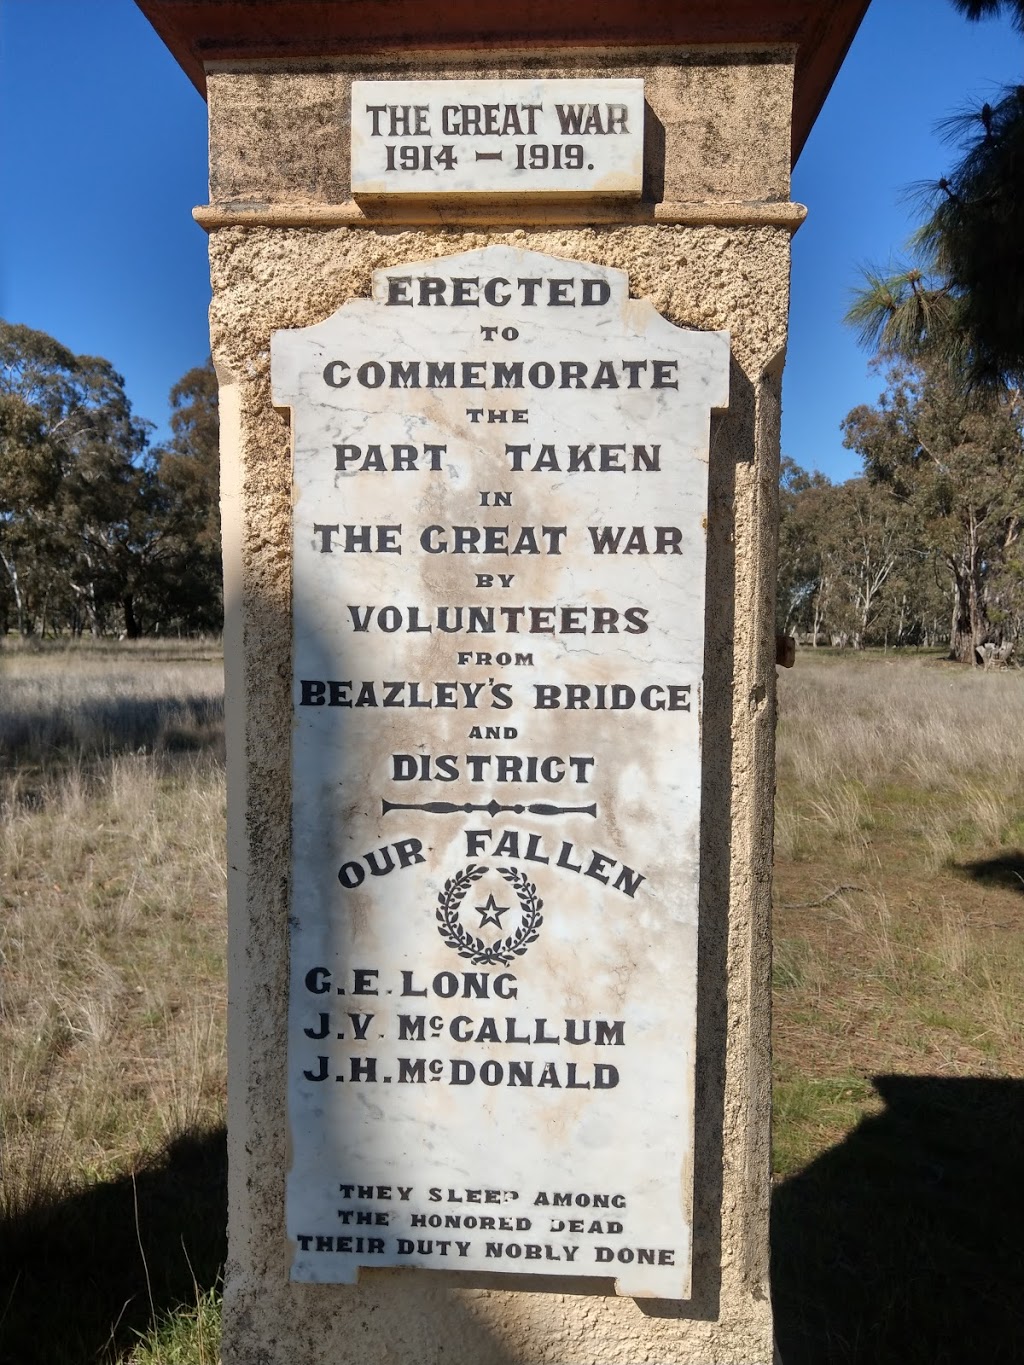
[771,1076,1024,1365]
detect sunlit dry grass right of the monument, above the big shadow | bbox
[774,651,1024,1173]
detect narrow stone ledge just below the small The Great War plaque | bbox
[193,199,807,232]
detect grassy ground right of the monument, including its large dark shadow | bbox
[773,651,1024,1365]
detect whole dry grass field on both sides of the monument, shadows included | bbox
[0,642,1024,1365]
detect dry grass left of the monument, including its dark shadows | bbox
[0,642,225,1365]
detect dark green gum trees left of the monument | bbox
[0,321,221,637]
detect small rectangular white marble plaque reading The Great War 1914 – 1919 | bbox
[352,81,643,198]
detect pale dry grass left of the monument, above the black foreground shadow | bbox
[0,654,225,1208]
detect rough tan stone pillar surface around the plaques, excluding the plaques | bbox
[208,49,801,1365]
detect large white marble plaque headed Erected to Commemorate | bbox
[272,246,729,1298]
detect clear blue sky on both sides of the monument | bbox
[0,0,1024,479]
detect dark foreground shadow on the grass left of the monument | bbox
[0,1129,227,1365]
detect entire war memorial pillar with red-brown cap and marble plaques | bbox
[139,0,866,1365]
